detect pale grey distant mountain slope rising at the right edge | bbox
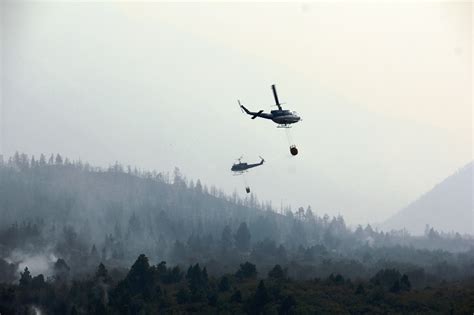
[381,162,474,234]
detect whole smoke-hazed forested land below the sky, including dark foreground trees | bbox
[0,153,474,314]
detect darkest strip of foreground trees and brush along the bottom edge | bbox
[0,255,474,314]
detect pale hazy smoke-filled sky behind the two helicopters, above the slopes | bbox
[0,1,473,224]
